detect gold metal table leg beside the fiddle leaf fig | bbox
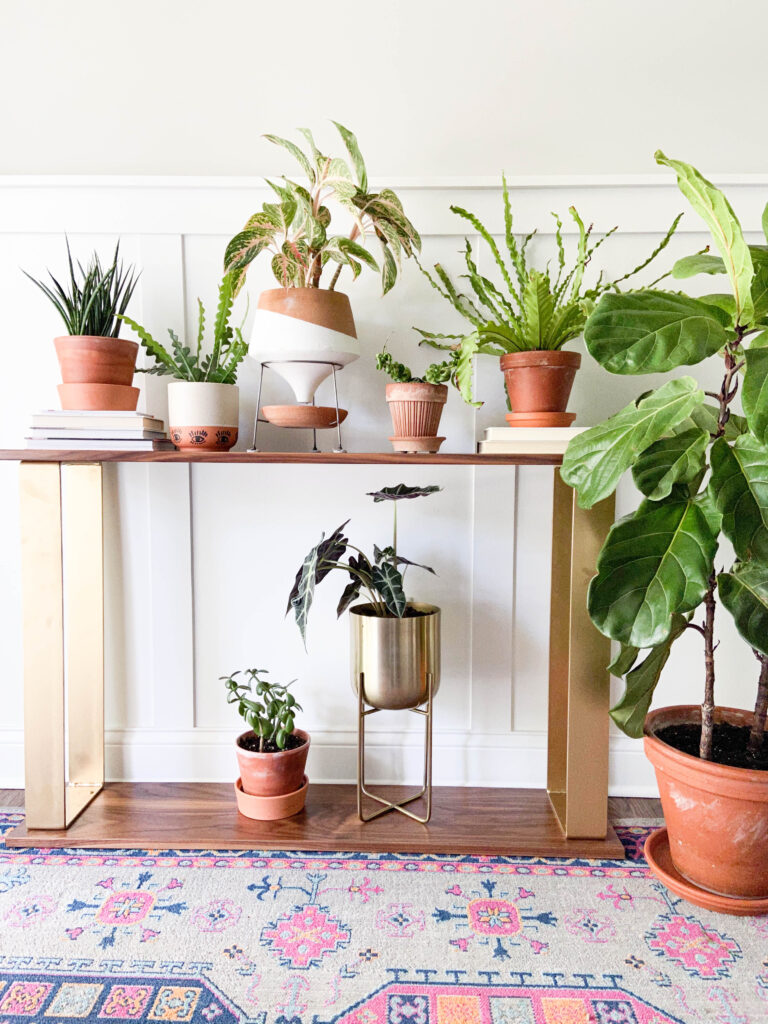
[547,469,614,839]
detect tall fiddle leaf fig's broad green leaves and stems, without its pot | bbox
[561,152,768,764]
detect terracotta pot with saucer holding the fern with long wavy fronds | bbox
[500,351,582,426]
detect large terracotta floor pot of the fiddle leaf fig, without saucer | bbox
[644,706,768,899]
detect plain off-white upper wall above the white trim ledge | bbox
[0,0,768,177]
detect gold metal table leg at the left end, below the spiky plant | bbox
[19,462,104,828]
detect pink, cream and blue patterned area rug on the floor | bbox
[0,812,768,1024]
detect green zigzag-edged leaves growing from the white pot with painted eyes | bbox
[122,274,248,384]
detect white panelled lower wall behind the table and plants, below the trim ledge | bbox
[0,178,768,793]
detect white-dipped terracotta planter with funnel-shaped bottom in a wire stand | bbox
[250,288,360,404]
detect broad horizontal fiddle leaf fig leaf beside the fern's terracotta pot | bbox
[584,290,731,374]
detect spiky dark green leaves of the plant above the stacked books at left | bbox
[22,239,138,338]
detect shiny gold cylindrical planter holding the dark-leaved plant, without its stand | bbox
[349,602,440,711]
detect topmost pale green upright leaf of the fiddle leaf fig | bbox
[655,150,755,325]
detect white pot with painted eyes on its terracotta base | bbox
[168,381,240,452]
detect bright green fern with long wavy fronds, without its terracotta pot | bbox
[415,176,682,402]
